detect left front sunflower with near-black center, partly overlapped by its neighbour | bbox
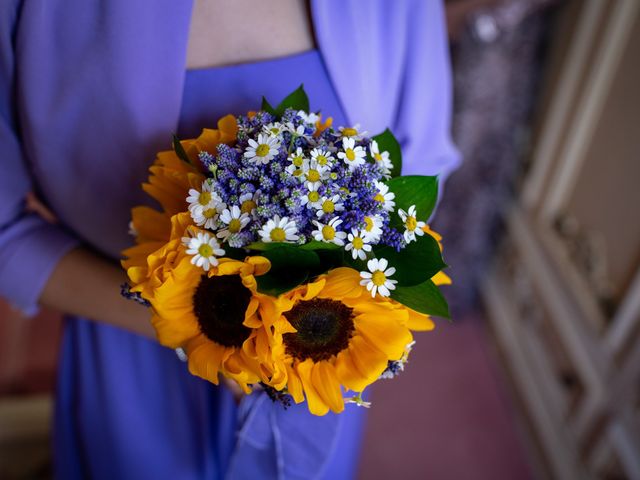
[146,247,274,393]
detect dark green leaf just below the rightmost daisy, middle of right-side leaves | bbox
[373,233,447,286]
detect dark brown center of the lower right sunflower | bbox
[283,298,354,362]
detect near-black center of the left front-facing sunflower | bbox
[193,275,251,347]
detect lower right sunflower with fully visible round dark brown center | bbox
[265,267,413,415]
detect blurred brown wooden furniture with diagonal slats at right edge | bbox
[484,0,640,480]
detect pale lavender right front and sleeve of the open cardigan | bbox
[312,0,460,180]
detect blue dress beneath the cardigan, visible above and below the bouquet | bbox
[54,50,364,480]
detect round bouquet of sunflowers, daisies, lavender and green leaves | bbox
[122,87,449,415]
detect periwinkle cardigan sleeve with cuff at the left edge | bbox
[0,1,79,314]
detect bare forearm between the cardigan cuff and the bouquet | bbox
[40,248,156,339]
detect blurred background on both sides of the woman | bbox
[0,0,640,480]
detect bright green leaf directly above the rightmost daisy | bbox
[386,175,438,227]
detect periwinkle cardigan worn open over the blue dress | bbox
[0,0,459,311]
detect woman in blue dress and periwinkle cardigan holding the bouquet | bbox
[0,0,457,478]
